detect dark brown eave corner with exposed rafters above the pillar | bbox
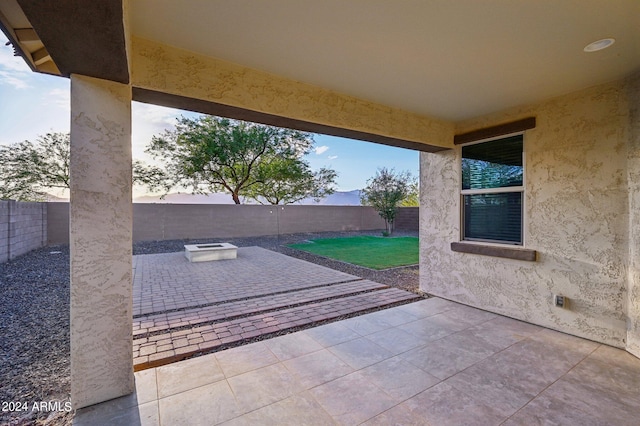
[0,0,129,83]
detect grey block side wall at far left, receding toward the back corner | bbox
[0,200,47,262]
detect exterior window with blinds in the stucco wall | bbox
[461,134,524,245]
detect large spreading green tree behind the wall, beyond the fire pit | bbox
[138,116,335,204]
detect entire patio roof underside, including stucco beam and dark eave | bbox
[0,0,640,151]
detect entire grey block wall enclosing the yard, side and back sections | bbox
[0,200,419,256]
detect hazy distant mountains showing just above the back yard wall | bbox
[133,189,360,206]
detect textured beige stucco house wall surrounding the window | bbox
[420,75,631,347]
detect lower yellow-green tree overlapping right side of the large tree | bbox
[243,157,337,204]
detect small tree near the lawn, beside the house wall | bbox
[360,167,414,235]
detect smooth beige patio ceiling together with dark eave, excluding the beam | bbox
[0,0,640,122]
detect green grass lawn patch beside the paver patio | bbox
[289,236,418,269]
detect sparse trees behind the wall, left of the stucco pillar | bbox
[0,133,69,201]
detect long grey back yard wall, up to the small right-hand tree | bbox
[47,203,384,244]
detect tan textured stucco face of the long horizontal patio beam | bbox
[131,37,453,148]
